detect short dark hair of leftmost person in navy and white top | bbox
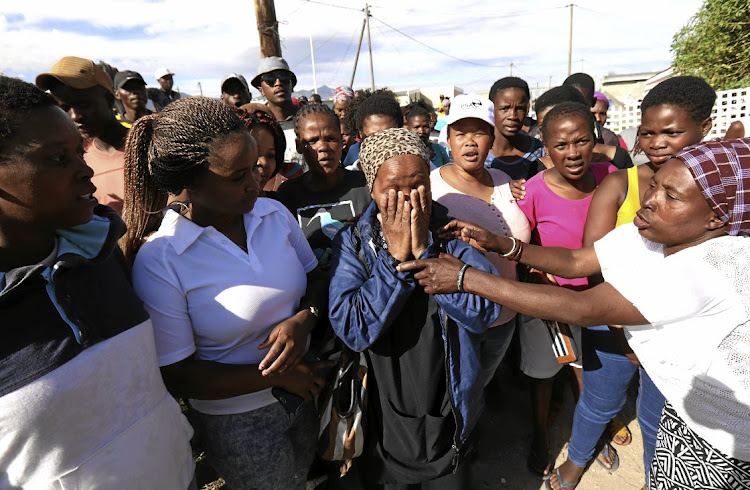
[0,75,57,154]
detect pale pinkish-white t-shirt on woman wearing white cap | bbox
[430,164,531,327]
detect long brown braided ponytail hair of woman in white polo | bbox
[120,97,247,264]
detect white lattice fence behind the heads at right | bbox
[606,87,750,139]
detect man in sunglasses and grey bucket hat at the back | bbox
[251,56,304,179]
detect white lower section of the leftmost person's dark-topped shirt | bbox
[0,320,195,490]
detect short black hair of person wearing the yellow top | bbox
[641,76,716,123]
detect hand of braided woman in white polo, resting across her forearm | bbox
[258,314,310,376]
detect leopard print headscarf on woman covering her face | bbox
[359,128,430,191]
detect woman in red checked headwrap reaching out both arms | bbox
[399,138,750,489]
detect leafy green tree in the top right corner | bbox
[672,0,750,90]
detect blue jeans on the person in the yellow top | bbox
[568,327,664,478]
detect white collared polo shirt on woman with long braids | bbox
[133,198,317,415]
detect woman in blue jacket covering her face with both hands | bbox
[329,128,500,488]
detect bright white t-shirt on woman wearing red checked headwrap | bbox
[594,224,750,461]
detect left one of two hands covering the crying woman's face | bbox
[378,189,412,262]
